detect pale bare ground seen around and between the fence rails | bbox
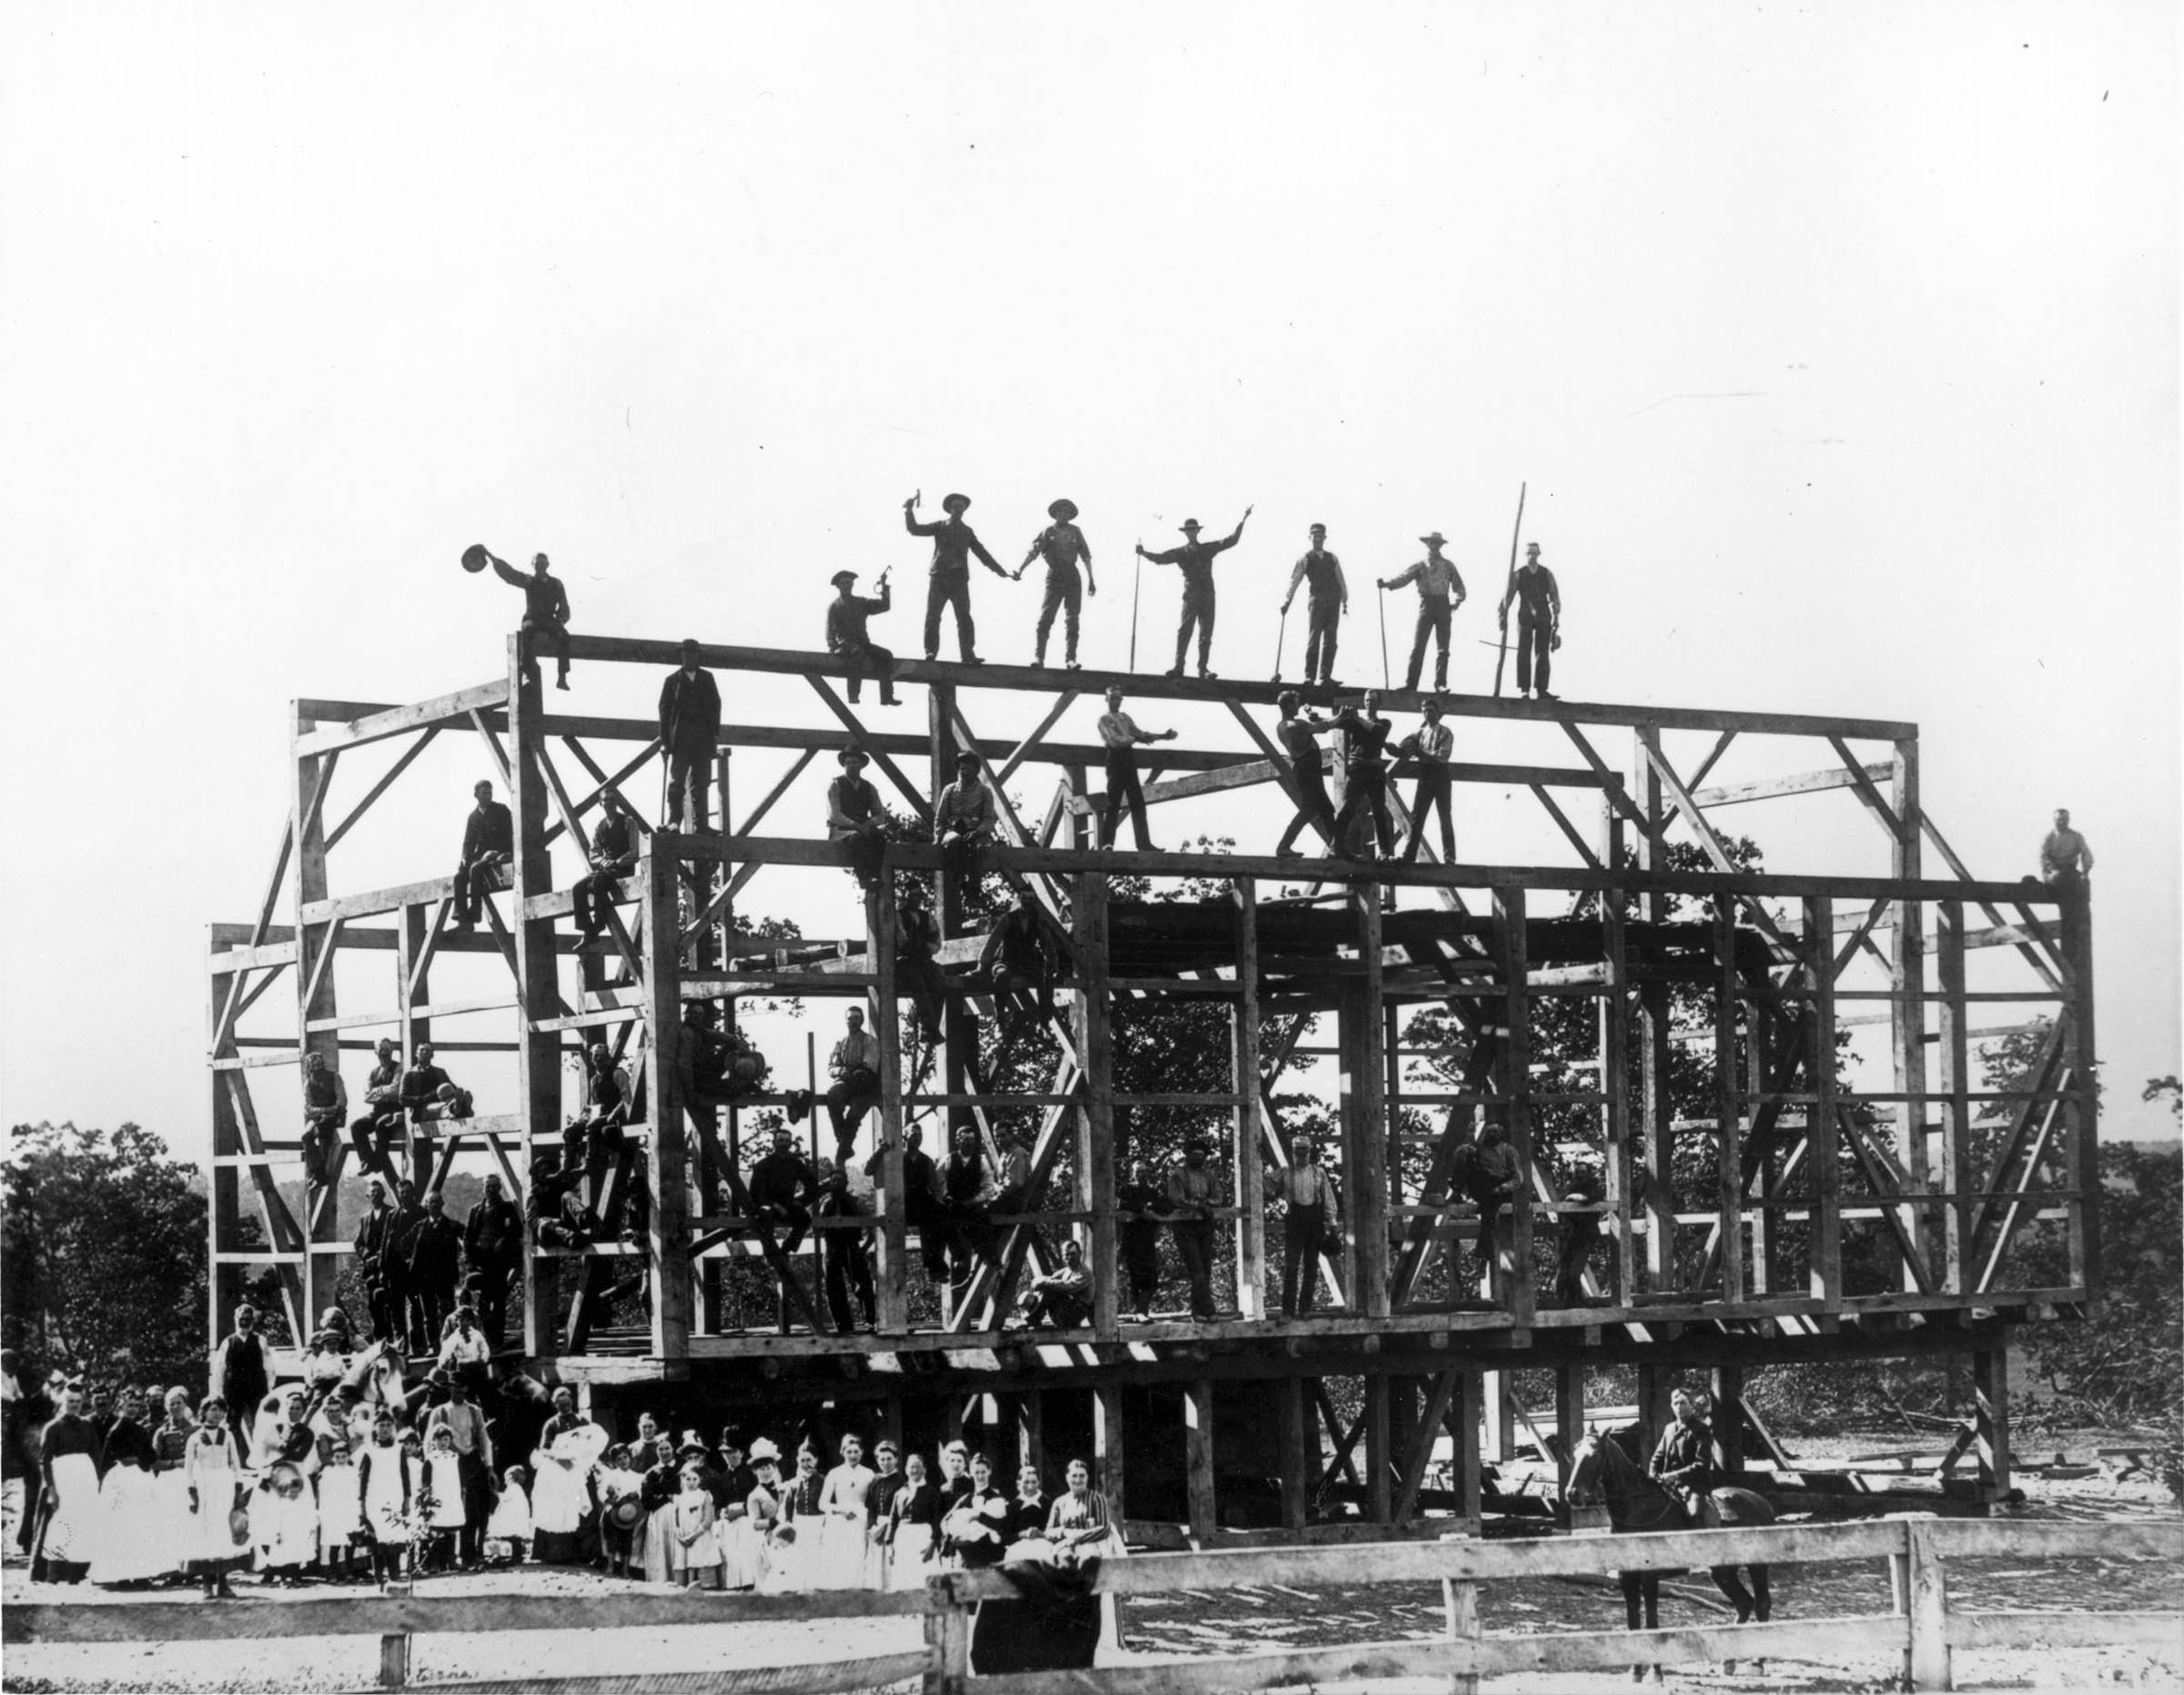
[0,1470,2184,1695]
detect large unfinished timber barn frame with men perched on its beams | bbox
[207,636,2101,1542]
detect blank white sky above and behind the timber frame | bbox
[0,0,2179,1154]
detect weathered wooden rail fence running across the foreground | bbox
[0,1518,2184,1695]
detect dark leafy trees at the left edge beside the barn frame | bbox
[0,1123,207,1385]
